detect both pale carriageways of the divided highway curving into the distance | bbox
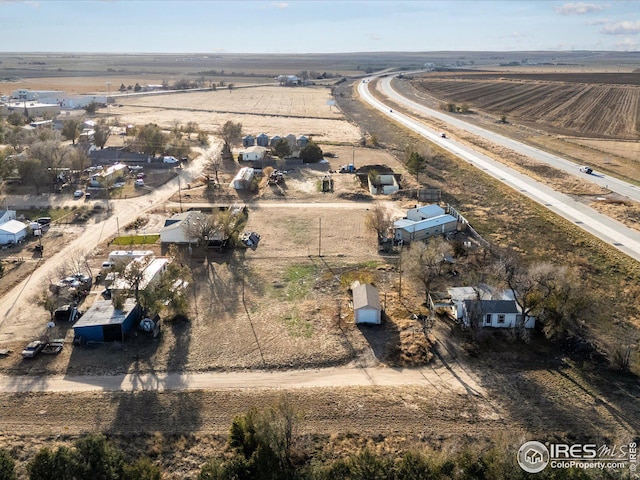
[358,78,640,261]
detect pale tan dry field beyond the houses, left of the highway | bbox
[111,86,361,143]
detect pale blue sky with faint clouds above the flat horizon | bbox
[0,0,640,53]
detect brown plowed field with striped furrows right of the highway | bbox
[413,74,640,139]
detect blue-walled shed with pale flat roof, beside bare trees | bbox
[73,298,141,343]
